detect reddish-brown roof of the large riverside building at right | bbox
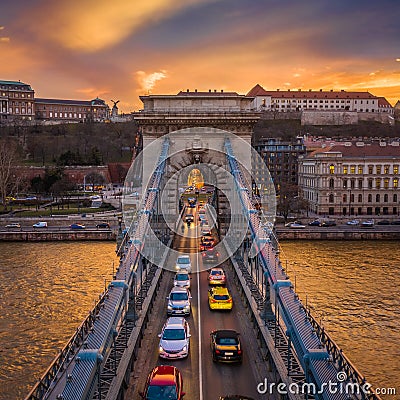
[305,142,400,159]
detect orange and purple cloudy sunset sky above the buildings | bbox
[0,0,400,112]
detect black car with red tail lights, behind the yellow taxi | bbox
[210,329,243,363]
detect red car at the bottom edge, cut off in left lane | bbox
[139,365,185,400]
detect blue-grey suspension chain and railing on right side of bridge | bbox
[225,139,379,400]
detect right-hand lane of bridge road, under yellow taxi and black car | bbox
[200,260,265,400]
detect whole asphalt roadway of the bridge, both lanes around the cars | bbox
[125,211,274,400]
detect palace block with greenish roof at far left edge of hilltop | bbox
[0,80,35,123]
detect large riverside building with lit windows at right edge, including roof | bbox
[299,140,400,216]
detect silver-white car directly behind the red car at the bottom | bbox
[158,317,190,359]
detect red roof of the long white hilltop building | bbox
[246,84,377,99]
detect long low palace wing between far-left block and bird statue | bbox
[35,97,110,122]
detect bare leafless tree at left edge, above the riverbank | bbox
[0,140,20,210]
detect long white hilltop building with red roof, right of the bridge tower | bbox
[247,84,393,114]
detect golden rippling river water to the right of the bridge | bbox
[281,241,400,399]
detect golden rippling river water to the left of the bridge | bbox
[0,242,117,400]
